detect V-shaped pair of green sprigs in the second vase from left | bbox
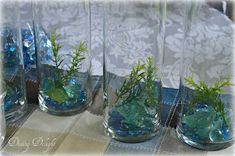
[50,32,87,84]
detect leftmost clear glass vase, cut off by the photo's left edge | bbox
[0,1,27,122]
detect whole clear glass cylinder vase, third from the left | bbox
[103,1,163,142]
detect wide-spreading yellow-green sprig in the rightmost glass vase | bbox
[185,76,233,126]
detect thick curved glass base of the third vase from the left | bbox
[103,122,160,143]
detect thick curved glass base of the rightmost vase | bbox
[176,128,234,151]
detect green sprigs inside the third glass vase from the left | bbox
[117,57,157,105]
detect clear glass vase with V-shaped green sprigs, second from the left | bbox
[33,0,91,115]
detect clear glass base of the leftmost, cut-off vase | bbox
[6,104,28,123]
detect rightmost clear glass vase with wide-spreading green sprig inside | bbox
[176,2,234,150]
